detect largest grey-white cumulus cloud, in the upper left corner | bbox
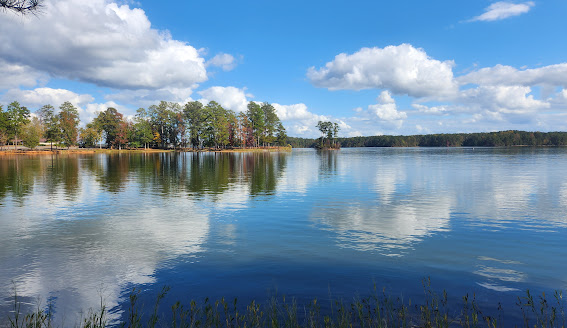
[0,0,207,89]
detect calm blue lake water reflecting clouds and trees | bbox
[0,148,567,325]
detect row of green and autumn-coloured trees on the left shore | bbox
[0,101,287,149]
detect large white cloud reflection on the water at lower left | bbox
[0,196,210,324]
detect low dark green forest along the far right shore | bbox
[287,130,567,148]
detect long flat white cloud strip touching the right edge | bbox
[457,63,567,87]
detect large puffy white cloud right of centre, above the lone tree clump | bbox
[307,44,457,97]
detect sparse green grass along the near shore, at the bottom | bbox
[0,280,566,328]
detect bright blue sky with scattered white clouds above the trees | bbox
[0,0,567,137]
